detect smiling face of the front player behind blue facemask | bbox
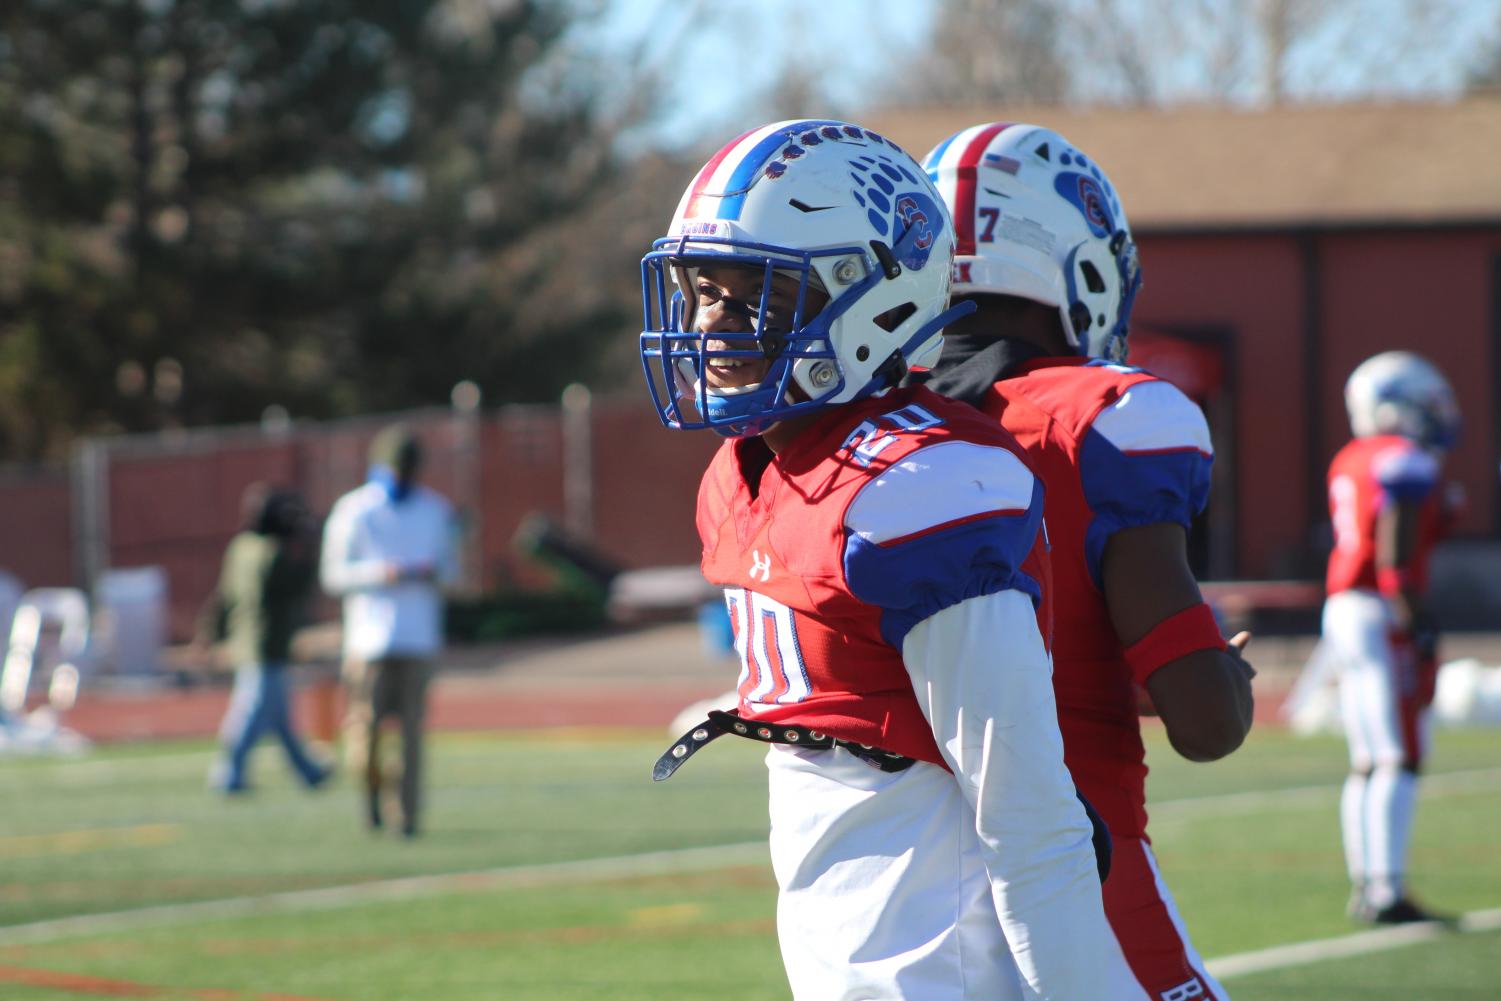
[693,267,829,389]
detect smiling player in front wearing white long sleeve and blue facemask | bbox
[641,120,1135,1001]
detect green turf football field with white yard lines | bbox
[0,728,1501,1001]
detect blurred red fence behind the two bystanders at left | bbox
[0,399,717,639]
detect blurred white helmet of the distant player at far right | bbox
[1345,351,1460,449]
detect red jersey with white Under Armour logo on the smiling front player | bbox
[698,387,1048,765]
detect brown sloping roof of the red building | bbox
[866,96,1501,231]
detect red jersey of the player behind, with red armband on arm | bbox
[980,359,1213,837]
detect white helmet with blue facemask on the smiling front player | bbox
[641,120,973,437]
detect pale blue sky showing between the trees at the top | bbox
[567,0,1501,149]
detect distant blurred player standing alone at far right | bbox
[1322,351,1459,924]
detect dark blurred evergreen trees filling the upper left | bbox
[0,0,629,458]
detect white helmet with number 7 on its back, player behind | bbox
[923,122,1141,362]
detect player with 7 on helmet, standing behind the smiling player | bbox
[925,123,1253,1001]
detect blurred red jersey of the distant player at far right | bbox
[1324,435,1448,594]
